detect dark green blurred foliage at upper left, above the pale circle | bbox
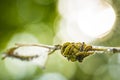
[0,0,59,49]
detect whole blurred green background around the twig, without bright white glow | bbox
[0,0,120,80]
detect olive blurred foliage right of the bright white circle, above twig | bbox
[92,0,120,46]
